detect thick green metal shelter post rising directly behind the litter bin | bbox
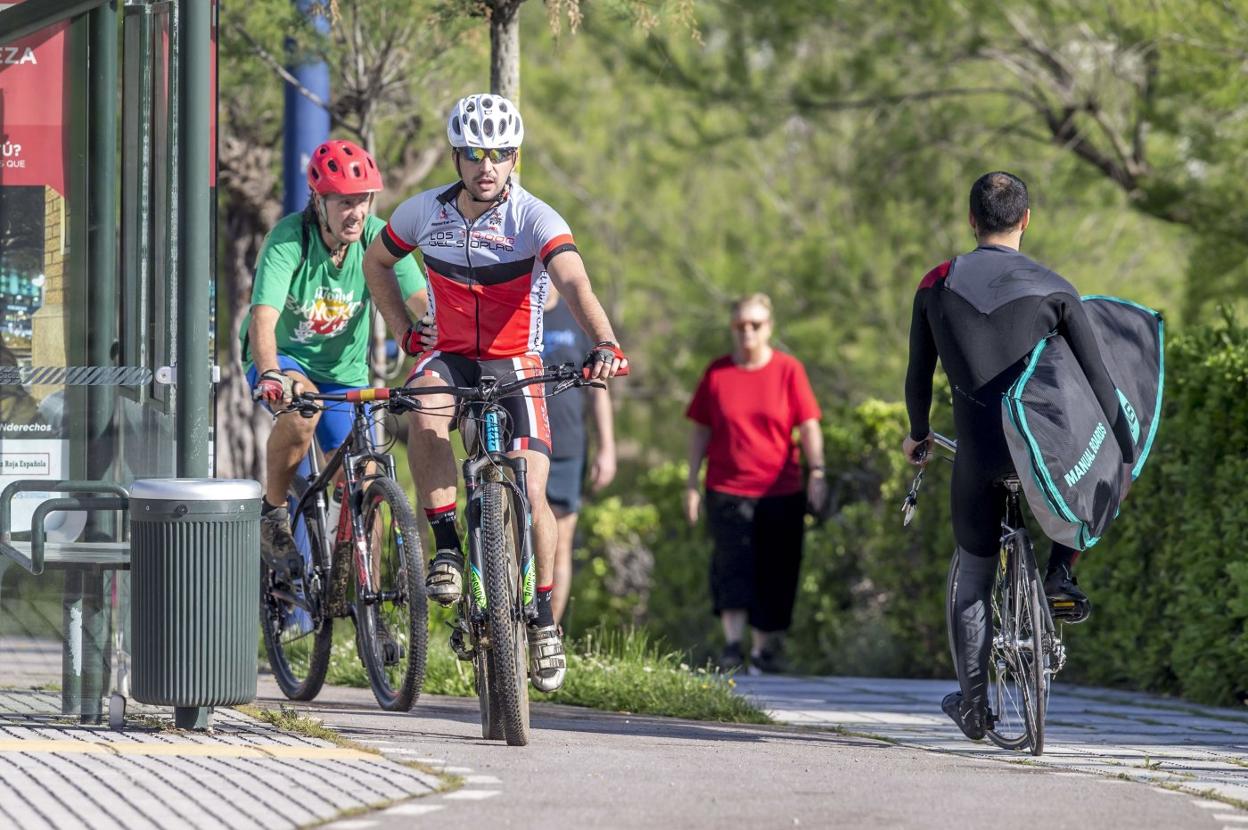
[175,0,216,477]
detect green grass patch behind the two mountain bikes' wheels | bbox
[328,613,771,724]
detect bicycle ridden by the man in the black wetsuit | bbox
[902,434,1066,755]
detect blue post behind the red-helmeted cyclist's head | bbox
[282,0,329,213]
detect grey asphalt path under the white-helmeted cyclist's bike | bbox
[257,678,1223,830]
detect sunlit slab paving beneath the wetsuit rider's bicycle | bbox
[736,675,1248,803]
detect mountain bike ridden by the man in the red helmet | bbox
[260,389,428,711]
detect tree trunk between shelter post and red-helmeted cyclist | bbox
[216,135,281,482]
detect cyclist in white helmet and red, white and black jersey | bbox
[364,94,628,691]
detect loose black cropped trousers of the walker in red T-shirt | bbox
[706,491,806,632]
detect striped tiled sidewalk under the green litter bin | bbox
[0,690,439,830]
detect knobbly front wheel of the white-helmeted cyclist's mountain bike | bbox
[480,482,529,746]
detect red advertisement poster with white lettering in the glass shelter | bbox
[0,2,66,195]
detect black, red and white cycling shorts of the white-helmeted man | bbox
[407,352,550,456]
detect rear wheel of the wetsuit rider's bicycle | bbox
[988,537,1047,755]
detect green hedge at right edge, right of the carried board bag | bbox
[1070,320,1248,704]
